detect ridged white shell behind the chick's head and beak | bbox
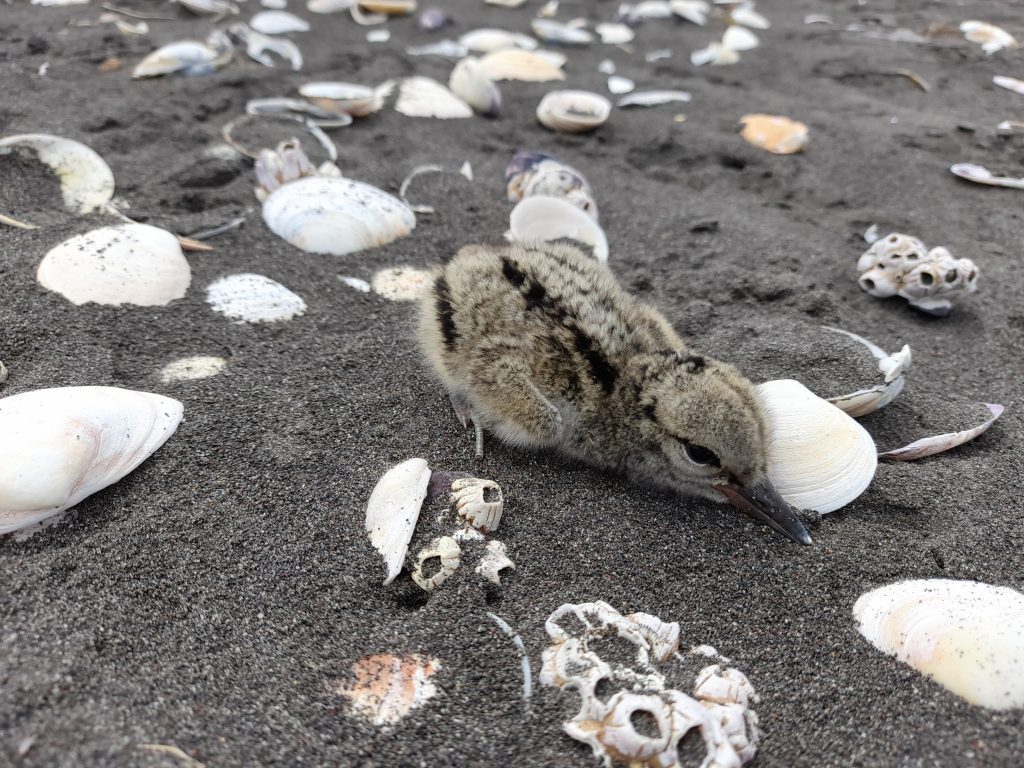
[758,379,878,513]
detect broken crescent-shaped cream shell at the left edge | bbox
[0,133,114,213]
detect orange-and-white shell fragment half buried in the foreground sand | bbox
[335,653,441,725]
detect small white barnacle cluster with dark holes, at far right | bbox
[857,232,979,317]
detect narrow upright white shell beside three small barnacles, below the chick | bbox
[367,459,430,586]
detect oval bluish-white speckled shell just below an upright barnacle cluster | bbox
[263,177,415,256]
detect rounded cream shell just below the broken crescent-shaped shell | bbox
[36,224,191,306]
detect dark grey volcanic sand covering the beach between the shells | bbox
[0,0,1024,768]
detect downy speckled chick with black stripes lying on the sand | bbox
[420,243,811,544]
